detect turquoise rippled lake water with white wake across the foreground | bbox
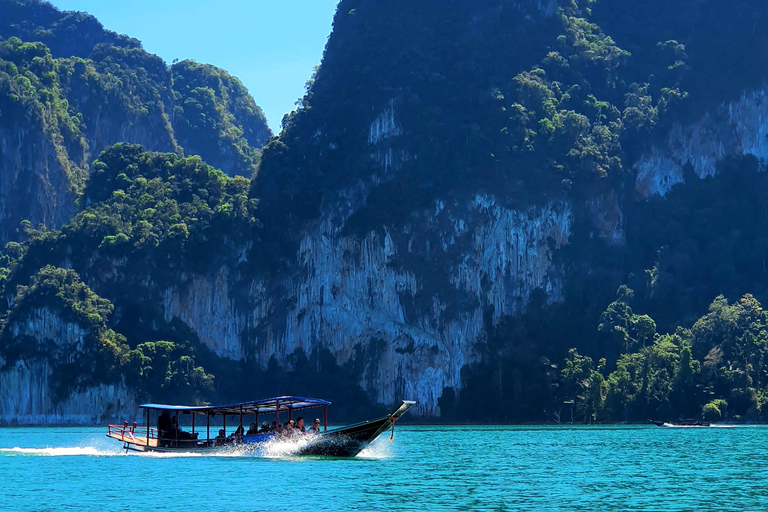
[0,426,768,512]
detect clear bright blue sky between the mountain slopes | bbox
[49,0,338,132]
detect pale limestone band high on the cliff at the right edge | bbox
[635,87,768,197]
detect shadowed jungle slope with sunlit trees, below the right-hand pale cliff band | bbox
[441,156,768,423]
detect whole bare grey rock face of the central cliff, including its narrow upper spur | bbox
[159,97,572,415]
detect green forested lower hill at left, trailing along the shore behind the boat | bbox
[0,144,381,419]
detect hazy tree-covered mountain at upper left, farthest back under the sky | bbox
[0,0,271,190]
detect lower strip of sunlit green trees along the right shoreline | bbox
[440,286,768,423]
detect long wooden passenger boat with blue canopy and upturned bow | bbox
[107,396,416,457]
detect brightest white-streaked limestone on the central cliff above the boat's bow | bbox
[240,196,572,414]
